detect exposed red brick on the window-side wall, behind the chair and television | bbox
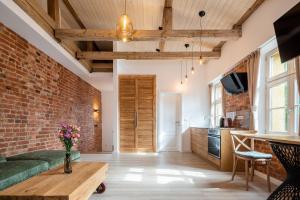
[223,65,286,180]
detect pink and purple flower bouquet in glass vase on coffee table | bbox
[57,123,80,174]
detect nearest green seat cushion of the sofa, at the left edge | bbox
[0,160,49,190]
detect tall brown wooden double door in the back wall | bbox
[119,75,156,152]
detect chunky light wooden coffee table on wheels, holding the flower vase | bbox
[0,162,108,200]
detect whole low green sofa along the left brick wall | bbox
[0,150,80,190]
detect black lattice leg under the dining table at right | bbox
[268,142,300,200]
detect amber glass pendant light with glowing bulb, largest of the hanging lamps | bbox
[117,0,133,42]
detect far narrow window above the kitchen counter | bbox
[210,82,223,127]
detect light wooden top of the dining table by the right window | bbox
[230,131,300,145]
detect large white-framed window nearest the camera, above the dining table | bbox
[266,50,300,133]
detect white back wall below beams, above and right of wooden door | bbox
[117,60,209,151]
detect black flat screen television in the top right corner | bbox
[274,2,300,63]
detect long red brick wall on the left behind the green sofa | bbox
[0,24,101,156]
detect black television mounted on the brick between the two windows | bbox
[221,72,248,94]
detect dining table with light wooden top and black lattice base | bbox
[231,130,300,200]
